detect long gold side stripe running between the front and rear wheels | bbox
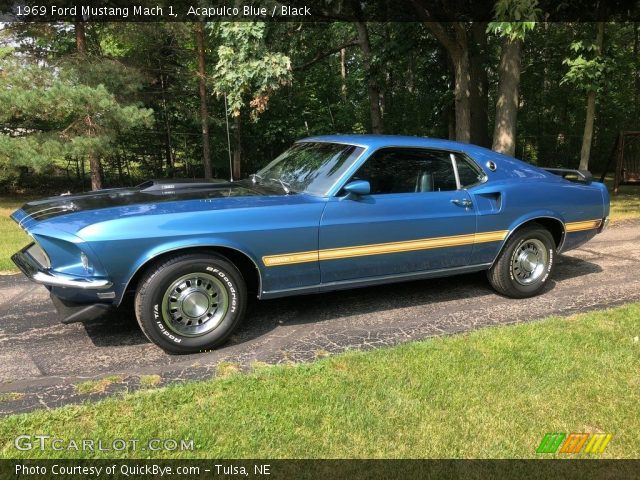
[262,230,509,267]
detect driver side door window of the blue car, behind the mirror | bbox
[353,148,457,195]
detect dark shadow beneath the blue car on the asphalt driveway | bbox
[79,255,602,350]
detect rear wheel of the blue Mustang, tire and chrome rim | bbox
[487,225,556,298]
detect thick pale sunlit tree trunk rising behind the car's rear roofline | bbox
[492,37,522,156]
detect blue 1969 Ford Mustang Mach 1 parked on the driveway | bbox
[12,135,609,353]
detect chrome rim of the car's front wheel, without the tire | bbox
[162,273,229,337]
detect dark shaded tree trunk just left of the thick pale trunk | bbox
[469,22,491,147]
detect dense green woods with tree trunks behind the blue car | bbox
[0,12,640,192]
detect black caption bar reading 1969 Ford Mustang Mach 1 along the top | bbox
[0,0,640,22]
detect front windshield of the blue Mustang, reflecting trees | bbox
[256,142,364,195]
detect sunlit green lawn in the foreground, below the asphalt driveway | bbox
[0,304,640,458]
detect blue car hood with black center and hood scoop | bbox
[11,180,316,234]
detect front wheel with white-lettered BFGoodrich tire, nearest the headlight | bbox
[135,254,247,354]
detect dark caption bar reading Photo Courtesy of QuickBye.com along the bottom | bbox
[0,459,640,480]
